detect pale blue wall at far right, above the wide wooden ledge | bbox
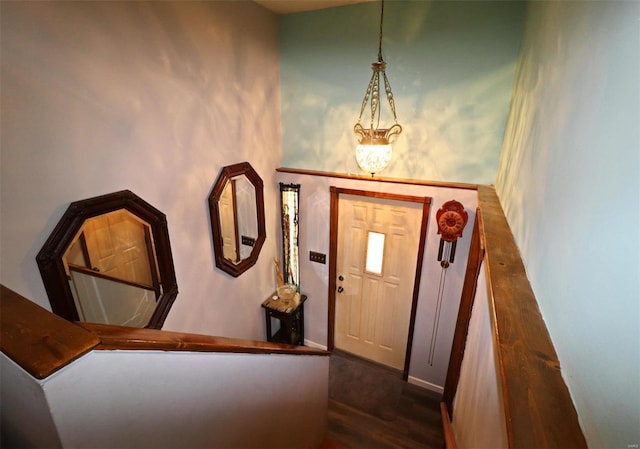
[497,1,640,448]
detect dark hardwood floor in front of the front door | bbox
[327,351,444,449]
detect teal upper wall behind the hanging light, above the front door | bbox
[279,1,526,183]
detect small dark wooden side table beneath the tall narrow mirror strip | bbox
[262,293,307,346]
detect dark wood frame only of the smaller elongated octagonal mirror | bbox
[209,162,266,277]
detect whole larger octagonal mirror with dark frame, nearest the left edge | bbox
[36,190,178,329]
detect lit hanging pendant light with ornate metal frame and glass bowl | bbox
[353,0,402,176]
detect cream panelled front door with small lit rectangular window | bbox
[334,195,423,369]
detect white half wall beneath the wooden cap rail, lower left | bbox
[2,351,329,449]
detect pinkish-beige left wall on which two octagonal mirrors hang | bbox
[0,1,281,339]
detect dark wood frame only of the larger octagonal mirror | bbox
[36,190,178,329]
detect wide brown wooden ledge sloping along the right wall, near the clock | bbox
[478,186,587,448]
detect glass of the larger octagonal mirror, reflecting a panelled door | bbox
[62,209,161,327]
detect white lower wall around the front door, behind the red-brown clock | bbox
[278,173,477,392]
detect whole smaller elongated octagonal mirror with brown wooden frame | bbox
[209,162,266,277]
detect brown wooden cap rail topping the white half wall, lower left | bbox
[0,285,329,379]
